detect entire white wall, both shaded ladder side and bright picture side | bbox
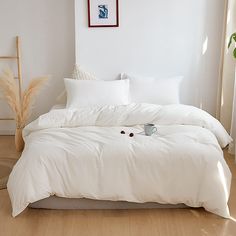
[0,0,227,133]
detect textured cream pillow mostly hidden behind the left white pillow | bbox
[56,65,97,104]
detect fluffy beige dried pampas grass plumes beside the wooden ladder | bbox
[0,69,48,128]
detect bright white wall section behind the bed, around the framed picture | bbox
[76,0,224,115]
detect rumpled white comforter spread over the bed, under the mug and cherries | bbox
[8,104,231,217]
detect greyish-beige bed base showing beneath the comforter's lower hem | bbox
[29,196,188,210]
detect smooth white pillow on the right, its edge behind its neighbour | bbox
[121,74,183,105]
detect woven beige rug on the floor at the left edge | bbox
[0,158,16,190]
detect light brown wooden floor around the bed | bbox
[0,137,236,236]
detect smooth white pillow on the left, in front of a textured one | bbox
[64,78,129,108]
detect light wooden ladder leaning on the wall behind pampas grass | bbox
[0,36,22,121]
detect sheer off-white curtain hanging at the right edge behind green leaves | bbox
[220,0,236,160]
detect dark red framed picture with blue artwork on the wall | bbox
[88,0,119,27]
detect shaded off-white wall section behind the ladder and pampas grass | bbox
[0,0,75,133]
